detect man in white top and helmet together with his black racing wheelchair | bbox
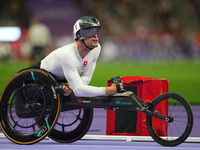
[0,16,193,146]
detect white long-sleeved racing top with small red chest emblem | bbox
[40,43,105,97]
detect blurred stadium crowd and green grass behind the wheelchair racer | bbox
[0,0,200,104]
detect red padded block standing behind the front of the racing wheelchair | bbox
[106,76,168,136]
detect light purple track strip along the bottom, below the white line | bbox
[0,139,200,150]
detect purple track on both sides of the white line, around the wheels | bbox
[0,106,200,150]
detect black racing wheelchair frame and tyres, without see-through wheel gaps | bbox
[0,69,193,146]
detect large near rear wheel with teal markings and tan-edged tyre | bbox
[0,69,61,144]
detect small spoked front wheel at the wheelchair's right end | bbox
[147,93,193,146]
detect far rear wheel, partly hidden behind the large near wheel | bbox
[49,109,93,143]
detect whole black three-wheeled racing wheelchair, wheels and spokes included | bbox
[0,68,193,146]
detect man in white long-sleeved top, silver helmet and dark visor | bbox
[40,16,123,97]
